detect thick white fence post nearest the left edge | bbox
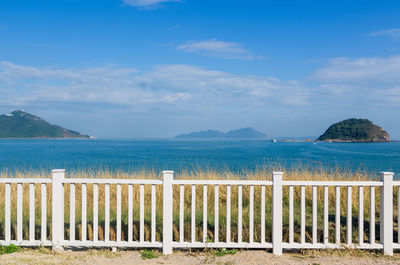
[51,169,65,250]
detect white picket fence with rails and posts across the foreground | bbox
[0,170,400,255]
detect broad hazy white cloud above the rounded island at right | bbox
[311,55,400,108]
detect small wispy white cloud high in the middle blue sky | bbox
[177,39,254,60]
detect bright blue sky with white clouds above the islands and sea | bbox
[0,0,400,136]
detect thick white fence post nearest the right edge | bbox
[380,172,394,256]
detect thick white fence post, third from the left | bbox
[272,172,283,256]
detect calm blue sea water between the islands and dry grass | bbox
[0,140,400,174]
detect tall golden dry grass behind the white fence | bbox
[0,169,397,242]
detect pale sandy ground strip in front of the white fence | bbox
[0,249,400,265]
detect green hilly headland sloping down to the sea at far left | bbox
[0,110,90,138]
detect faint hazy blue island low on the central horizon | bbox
[175,127,267,140]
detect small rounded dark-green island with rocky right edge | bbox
[317,118,390,142]
